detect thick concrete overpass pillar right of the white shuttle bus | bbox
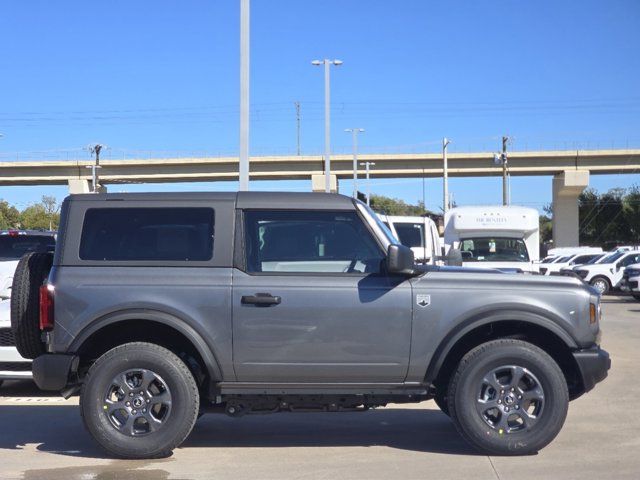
[553,170,589,247]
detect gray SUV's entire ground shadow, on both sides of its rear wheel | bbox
[0,405,478,458]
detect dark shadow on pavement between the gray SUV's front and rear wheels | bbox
[183,407,479,455]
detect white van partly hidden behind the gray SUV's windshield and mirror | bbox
[378,215,442,265]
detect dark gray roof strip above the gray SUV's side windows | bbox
[66,192,354,210]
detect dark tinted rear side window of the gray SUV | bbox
[80,207,214,261]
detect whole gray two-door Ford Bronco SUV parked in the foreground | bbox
[11,192,610,458]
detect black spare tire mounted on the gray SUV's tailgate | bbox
[11,253,53,359]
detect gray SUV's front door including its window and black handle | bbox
[233,210,411,383]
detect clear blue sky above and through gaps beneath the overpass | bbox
[0,0,640,209]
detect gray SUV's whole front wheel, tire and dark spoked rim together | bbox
[447,339,569,455]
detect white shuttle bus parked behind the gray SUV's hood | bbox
[444,206,540,272]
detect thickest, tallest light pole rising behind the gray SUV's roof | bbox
[238,0,250,191]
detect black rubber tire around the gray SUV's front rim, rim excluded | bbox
[447,339,569,455]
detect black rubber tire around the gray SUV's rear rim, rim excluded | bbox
[80,342,200,459]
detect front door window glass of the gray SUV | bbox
[244,210,384,273]
